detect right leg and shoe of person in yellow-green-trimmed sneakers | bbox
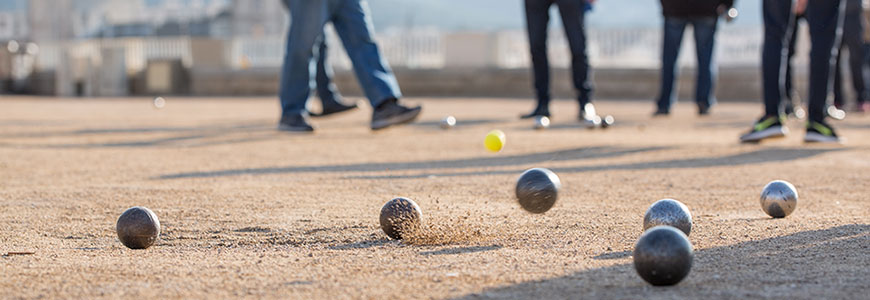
[804,0,845,142]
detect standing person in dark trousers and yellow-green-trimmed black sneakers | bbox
[740,0,846,143]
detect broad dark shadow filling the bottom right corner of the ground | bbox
[456,224,870,299]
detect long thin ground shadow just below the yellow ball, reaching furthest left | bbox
[156,147,666,179]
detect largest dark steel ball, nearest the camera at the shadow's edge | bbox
[633,226,695,285]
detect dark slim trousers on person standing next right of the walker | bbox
[525,0,592,107]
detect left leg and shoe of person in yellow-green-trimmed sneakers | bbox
[740,0,794,143]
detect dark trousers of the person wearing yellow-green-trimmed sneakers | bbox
[761,0,845,122]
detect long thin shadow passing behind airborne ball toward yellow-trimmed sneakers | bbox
[348,148,843,179]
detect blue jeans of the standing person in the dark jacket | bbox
[656,17,718,112]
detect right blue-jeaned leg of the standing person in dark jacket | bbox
[692,17,719,115]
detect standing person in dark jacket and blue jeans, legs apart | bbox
[653,0,734,116]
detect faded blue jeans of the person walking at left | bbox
[279,0,401,116]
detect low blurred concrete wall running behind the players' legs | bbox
[184,67,806,101]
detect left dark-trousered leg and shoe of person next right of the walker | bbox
[523,0,553,118]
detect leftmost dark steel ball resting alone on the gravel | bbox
[115,206,160,249]
